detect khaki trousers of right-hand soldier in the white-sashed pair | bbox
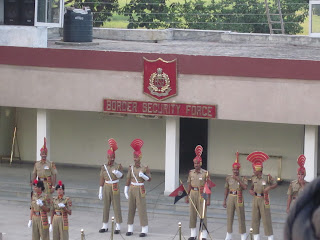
[128,185,148,227]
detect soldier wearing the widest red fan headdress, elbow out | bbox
[247,152,277,240]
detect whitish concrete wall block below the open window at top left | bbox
[0,25,48,48]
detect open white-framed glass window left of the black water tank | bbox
[34,0,64,27]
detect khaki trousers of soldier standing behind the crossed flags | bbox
[189,190,208,228]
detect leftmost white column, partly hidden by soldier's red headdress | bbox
[36,109,50,161]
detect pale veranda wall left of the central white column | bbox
[18,108,165,170]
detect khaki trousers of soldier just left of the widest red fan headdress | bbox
[227,194,246,234]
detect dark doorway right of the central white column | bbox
[179,118,208,174]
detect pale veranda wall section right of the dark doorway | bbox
[208,120,304,179]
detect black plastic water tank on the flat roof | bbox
[63,9,93,42]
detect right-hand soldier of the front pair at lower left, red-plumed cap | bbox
[49,181,72,240]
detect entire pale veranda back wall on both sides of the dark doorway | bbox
[18,108,304,179]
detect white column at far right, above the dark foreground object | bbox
[304,125,318,182]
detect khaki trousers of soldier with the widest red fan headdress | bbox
[252,196,273,236]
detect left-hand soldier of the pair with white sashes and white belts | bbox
[99,138,123,234]
